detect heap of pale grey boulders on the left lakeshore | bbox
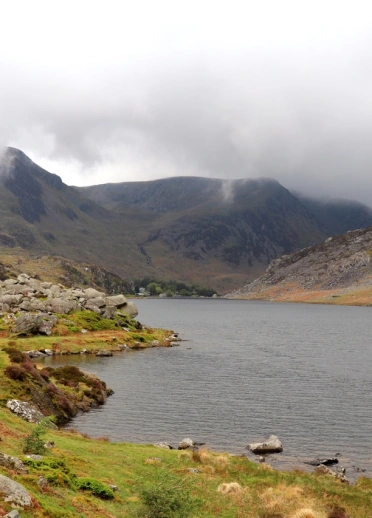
[0,273,138,335]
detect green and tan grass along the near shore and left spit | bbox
[0,329,372,518]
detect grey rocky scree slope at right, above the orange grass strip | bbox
[227,227,372,298]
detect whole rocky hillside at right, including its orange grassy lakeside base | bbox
[227,227,372,305]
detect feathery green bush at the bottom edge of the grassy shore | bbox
[139,470,200,518]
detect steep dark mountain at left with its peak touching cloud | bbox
[0,148,146,278]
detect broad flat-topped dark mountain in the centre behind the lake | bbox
[78,177,327,290]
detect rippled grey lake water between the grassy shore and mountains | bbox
[44,299,372,479]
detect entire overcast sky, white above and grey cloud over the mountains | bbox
[0,0,372,205]
